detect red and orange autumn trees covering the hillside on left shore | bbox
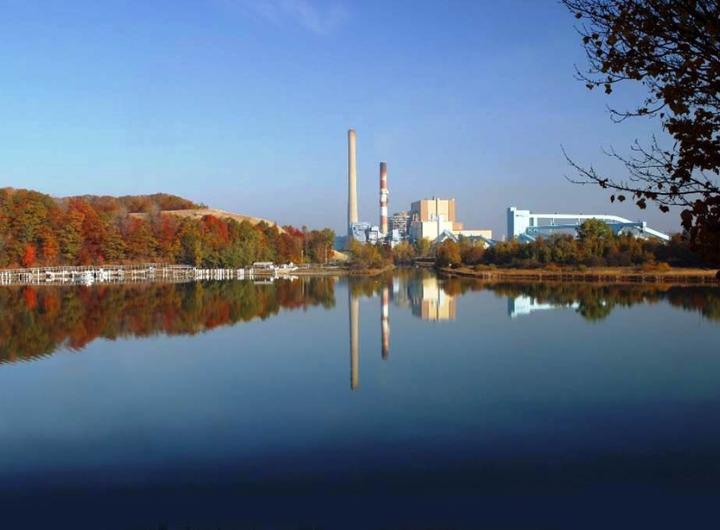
[0,188,335,268]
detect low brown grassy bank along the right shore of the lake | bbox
[438,267,718,284]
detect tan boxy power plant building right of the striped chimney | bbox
[409,198,492,241]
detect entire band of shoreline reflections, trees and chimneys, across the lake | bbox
[0,270,720,366]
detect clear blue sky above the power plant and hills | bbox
[0,0,679,237]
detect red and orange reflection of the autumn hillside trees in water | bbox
[0,278,335,363]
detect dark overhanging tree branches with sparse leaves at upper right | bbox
[561,0,720,261]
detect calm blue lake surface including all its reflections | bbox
[0,271,720,529]
